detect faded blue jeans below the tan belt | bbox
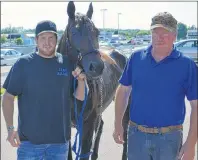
[128,125,183,160]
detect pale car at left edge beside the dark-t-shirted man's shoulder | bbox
[1,49,24,65]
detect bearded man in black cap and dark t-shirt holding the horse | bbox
[2,21,88,160]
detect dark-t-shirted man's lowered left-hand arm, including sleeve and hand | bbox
[2,60,24,147]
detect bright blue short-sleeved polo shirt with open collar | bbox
[119,46,198,127]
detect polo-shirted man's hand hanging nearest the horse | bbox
[113,124,124,144]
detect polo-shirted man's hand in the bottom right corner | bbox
[178,142,195,160]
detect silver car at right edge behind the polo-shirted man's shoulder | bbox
[175,39,198,63]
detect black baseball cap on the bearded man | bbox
[35,20,57,36]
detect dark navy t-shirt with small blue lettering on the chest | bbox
[3,53,73,144]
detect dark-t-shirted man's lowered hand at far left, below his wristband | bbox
[7,130,21,147]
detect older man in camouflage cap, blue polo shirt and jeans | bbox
[113,12,198,160]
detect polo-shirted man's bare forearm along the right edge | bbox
[186,100,198,147]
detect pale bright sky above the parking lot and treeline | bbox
[1,2,197,29]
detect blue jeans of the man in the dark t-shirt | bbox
[17,141,69,160]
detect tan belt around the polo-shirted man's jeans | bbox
[129,121,183,133]
